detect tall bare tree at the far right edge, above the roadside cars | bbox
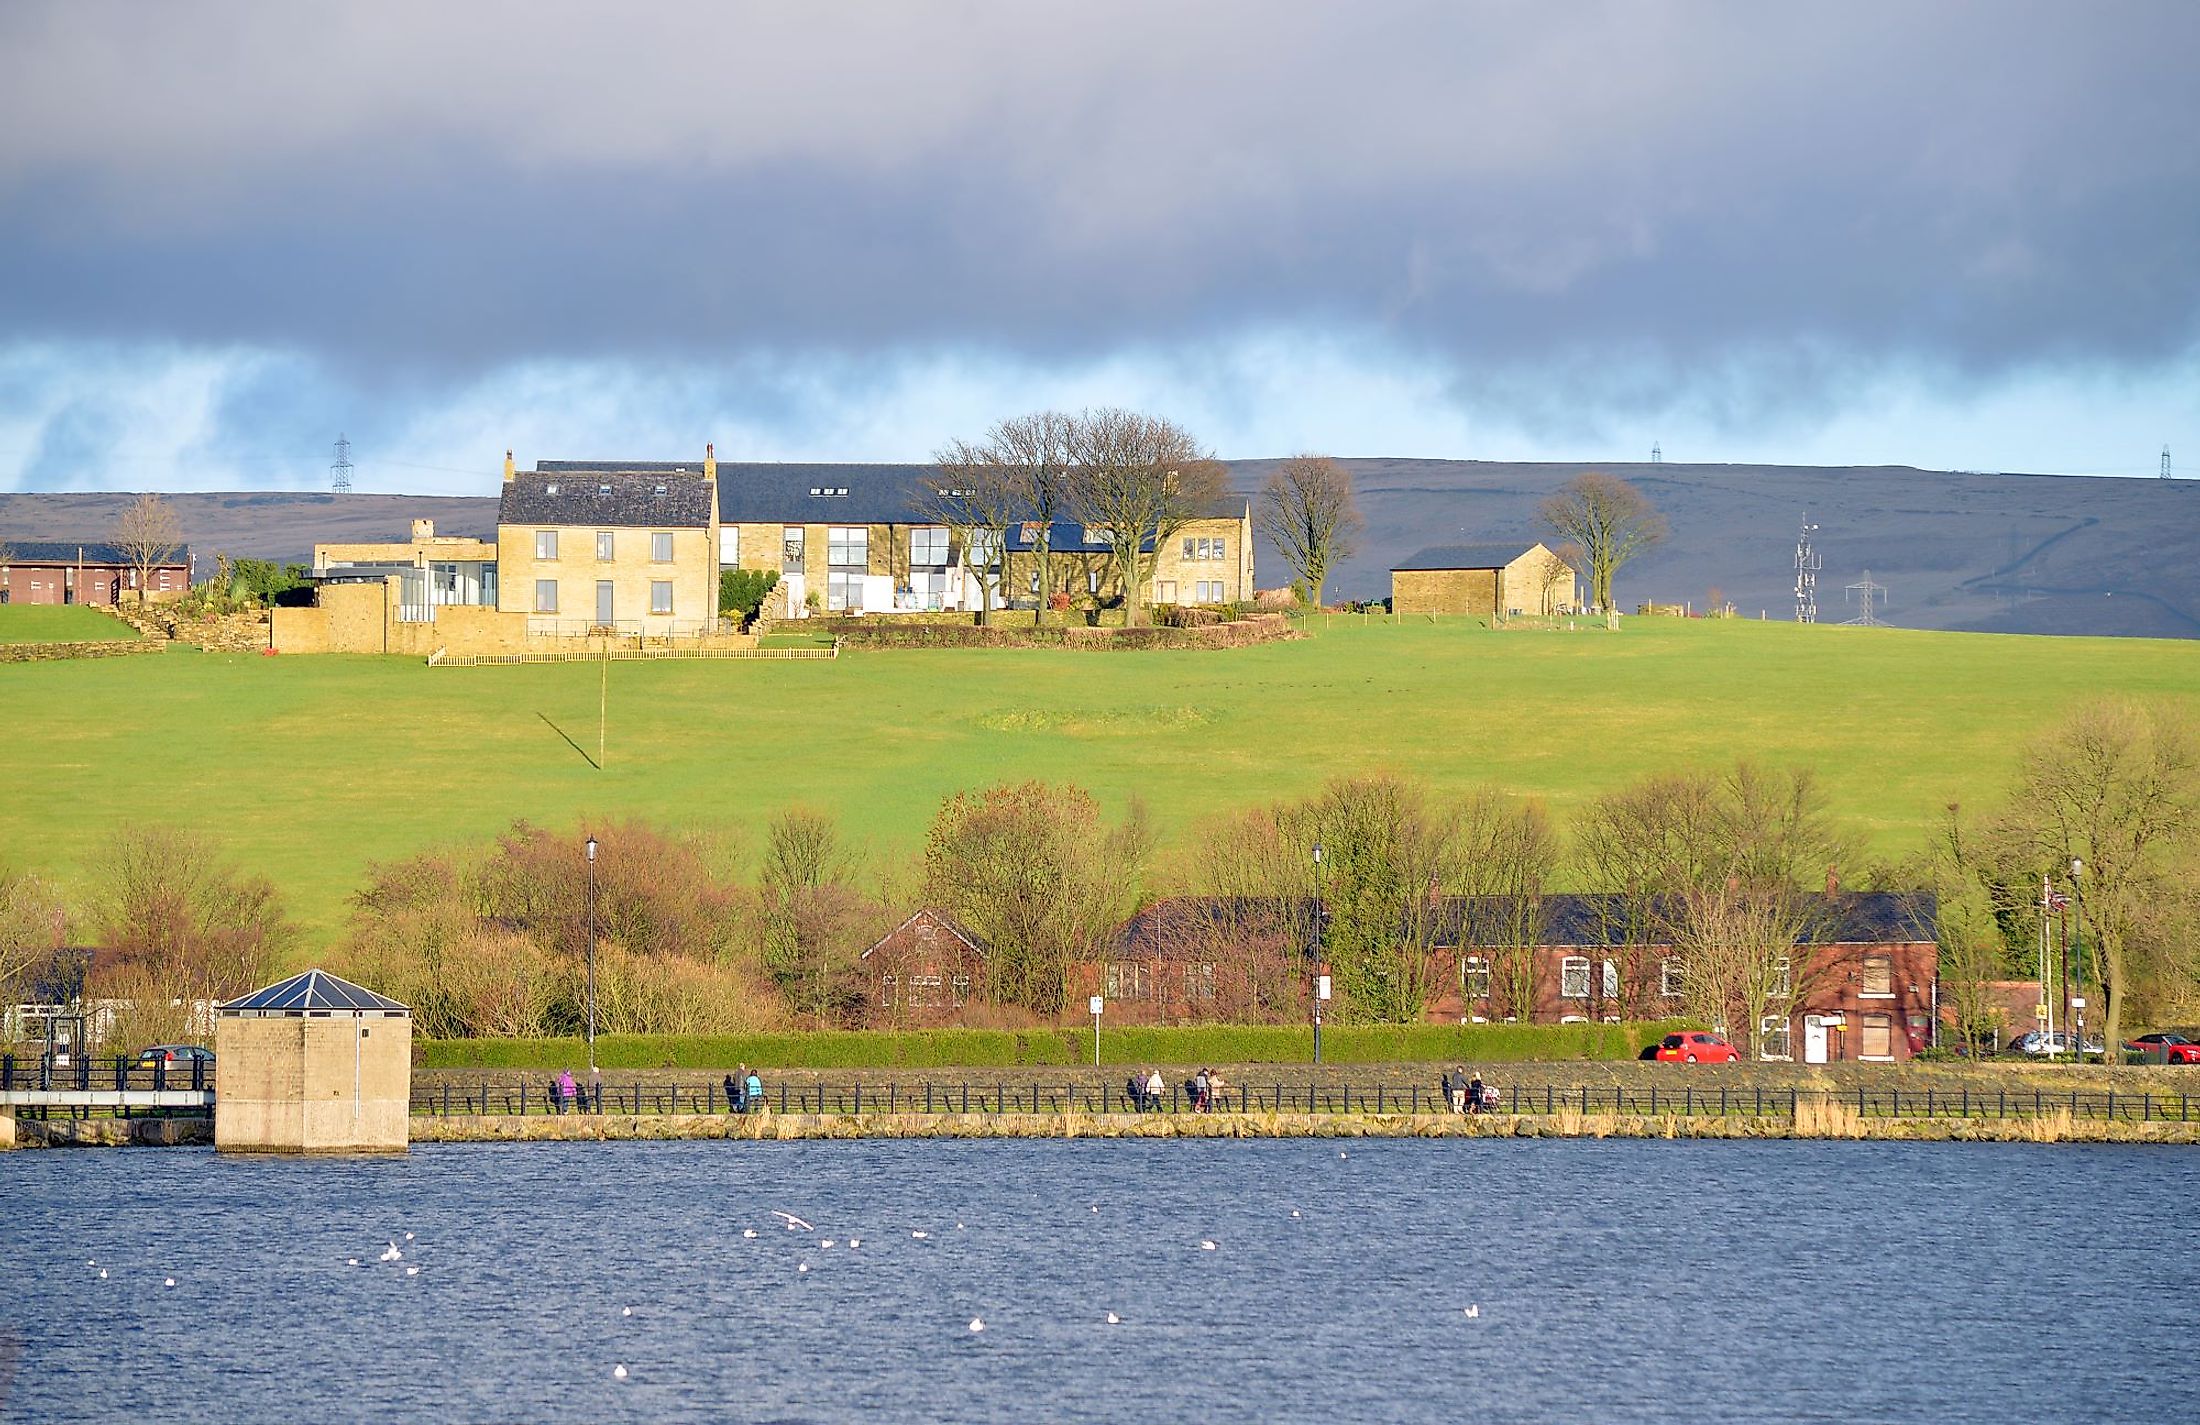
[2009,699,2200,1045]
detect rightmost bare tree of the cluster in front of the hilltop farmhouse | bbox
[1069,407,1225,627]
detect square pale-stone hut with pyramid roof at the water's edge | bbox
[213,970,411,1152]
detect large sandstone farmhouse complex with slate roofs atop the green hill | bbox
[273,446,1254,655]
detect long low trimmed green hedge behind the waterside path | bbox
[420,1023,1672,1069]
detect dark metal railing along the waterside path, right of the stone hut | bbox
[411,1078,2200,1124]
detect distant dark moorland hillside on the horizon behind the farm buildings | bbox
[0,460,2200,638]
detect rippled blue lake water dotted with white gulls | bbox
[0,1139,2200,1421]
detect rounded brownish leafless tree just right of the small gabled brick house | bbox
[924,783,1153,1014]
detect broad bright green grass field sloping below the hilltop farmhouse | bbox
[0,611,2200,950]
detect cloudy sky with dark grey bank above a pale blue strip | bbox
[0,0,2200,493]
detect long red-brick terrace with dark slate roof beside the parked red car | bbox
[1430,891,1940,1064]
